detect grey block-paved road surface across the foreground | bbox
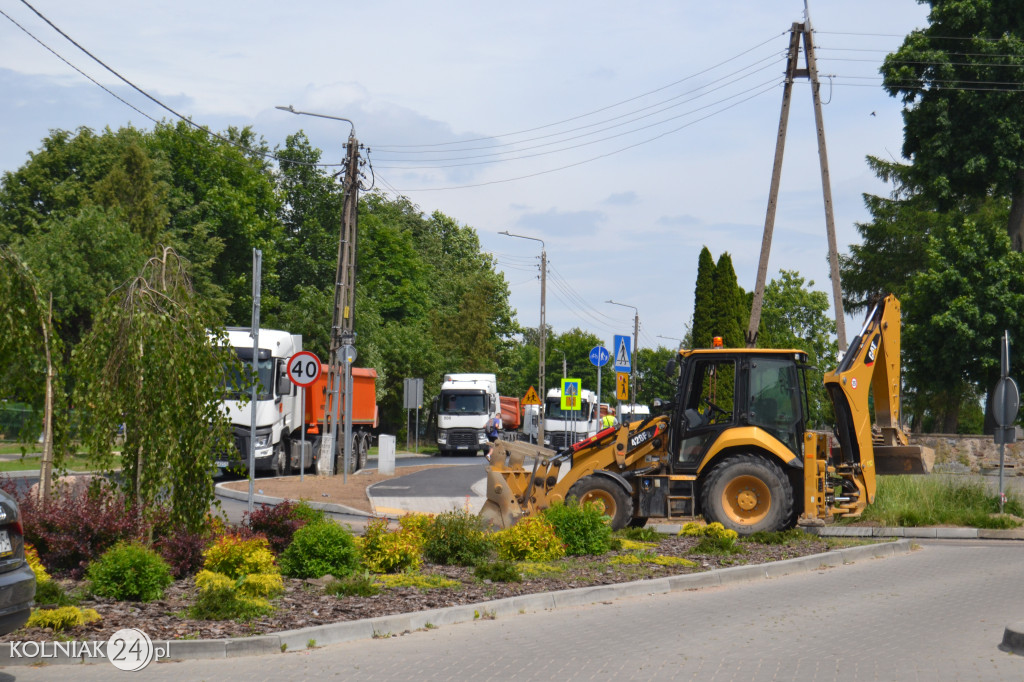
[0,541,1024,682]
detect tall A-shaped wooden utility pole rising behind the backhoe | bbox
[746,18,847,351]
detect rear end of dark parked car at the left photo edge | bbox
[0,491,36,635]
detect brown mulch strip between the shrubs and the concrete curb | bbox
[0,537,835,641]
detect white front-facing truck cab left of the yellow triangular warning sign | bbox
[434,374,502,457]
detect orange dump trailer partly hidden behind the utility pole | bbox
[293,365,380,472]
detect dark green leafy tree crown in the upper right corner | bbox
[881,0,1024,251]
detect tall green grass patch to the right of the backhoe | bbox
[853,476,1024,528]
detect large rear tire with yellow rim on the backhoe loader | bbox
[700,455,794,536]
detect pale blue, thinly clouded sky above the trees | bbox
[0,0,927,352]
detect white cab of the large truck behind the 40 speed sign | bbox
[217,327,302,475]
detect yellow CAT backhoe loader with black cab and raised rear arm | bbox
[480,296,934,535]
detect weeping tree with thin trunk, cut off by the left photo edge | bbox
[0,246,60,501]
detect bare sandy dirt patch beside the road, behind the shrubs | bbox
[224,464,454,513]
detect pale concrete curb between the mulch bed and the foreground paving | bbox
[0,540,913,667]
